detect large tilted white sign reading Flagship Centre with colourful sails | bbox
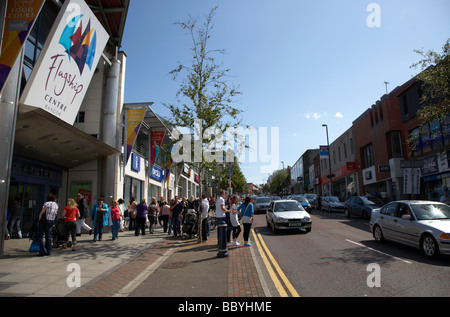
[20,0,109,124]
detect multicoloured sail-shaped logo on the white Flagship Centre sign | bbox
[59,14,97,75]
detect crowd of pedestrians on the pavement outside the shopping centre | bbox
[15,190,253,256]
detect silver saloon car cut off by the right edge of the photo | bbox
[370,200,450,257]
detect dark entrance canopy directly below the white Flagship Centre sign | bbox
[14,109,120,168]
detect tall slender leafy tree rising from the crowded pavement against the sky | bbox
[164,7,242,242]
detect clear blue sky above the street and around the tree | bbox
[121,0,450,184]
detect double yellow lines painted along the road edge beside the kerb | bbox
[251,229,300,297]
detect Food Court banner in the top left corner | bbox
[0,0,45,93]
